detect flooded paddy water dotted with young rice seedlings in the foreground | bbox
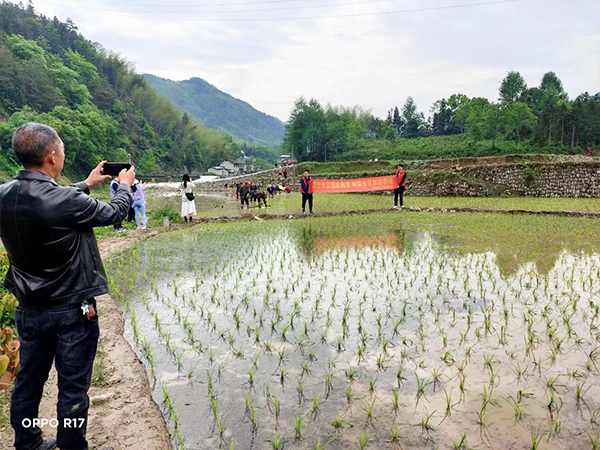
[105,215,600,449]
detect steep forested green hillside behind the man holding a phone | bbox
[0,2,240,176]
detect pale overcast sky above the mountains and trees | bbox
[25,0,600,121]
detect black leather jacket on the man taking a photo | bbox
[0,170,133,307]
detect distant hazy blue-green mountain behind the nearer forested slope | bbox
[144,74,284,147]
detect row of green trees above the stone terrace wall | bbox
[283,72,600,161]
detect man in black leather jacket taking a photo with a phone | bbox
[0,123,135,450]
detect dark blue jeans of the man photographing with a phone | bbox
[10,299,99,450]
